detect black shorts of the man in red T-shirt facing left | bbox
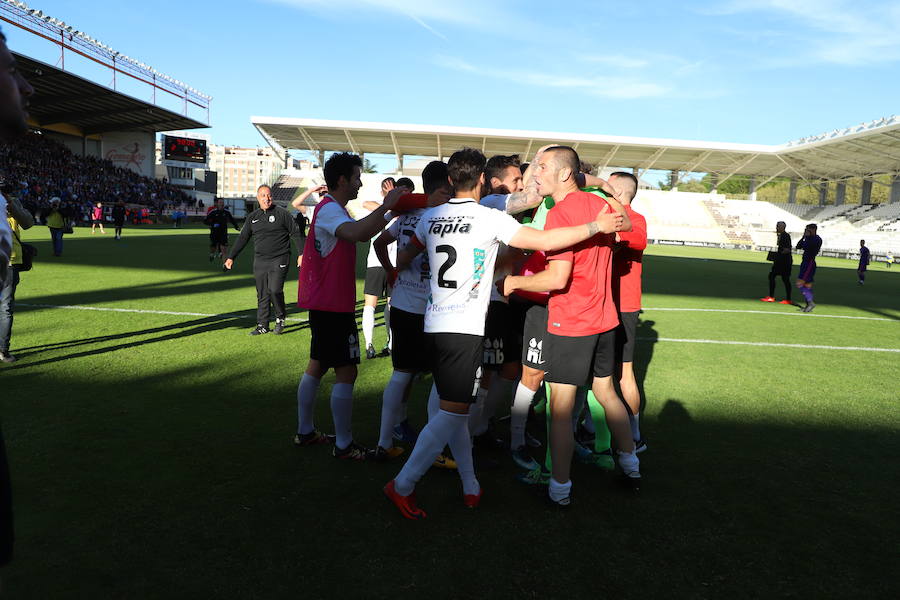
[545,329,616,386]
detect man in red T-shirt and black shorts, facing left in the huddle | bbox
[504,146,640,506]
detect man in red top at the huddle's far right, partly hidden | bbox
[609,171,647,452]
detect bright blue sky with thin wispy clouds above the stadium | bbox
[4,0,900,164]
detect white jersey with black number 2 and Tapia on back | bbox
[416,198,522,335]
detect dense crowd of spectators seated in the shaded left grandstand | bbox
[0,133,196,224]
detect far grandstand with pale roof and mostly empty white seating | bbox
[251,117,900,260]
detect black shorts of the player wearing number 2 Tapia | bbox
[425,333,484,404]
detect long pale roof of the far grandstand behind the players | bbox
[251,117,900,185]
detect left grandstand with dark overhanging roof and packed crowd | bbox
[0,0,211,223]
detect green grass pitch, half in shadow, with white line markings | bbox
[0,227,900,599]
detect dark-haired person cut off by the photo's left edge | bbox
[0,22,34,567]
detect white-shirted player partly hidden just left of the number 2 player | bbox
[372,160,455,466]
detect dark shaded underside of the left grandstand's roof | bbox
[13,52,208,135]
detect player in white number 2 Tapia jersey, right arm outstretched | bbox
[384,148,622,519]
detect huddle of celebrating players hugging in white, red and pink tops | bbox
[294,146,647,519]
